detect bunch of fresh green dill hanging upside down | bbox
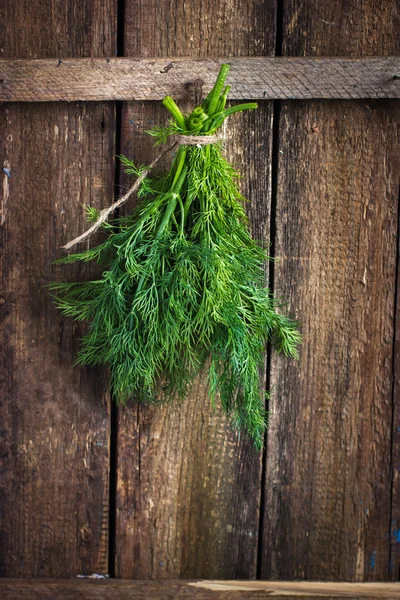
[51,65,300,448]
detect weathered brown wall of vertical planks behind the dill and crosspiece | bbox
[0,0,400,580]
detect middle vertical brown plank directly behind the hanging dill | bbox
[116,0,275,579]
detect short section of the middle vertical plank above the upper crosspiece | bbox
[124,0,276,58]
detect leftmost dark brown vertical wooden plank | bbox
[0,0,116,577]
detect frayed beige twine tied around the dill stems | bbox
[62,135,221,250]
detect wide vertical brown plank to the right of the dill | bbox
[261,0,400,580]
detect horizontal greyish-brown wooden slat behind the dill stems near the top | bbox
[0,57,400,102]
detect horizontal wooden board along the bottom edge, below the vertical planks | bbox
[0,579,400,600]
